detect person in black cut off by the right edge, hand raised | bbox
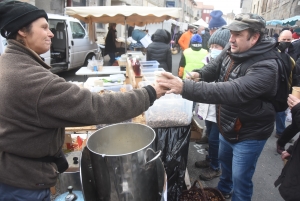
[274,94,300,200]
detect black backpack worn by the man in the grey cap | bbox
[240,48,295,112]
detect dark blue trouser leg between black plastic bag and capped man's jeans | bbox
[205,120,220,170]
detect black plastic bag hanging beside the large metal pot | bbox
[152,125,191,201]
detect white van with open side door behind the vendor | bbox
[0,14,101,73]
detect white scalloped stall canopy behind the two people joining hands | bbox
[66,6,181,26]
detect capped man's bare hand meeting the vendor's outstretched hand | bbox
[156,72,183,94]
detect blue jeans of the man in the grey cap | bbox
[218,135,267,201]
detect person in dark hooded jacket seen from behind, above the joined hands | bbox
[147,29,172,72]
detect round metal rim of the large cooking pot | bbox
[86,122,156,157]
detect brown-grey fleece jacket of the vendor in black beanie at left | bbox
[0,40,150,189]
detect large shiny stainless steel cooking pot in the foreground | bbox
[80,123,165,201]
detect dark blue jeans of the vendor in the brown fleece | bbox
[0,183,50,201]
